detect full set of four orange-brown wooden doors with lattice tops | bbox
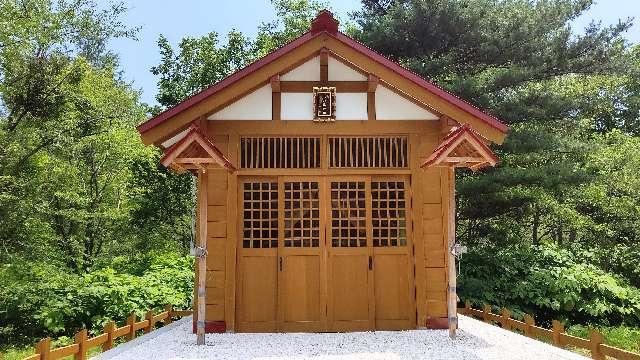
[237,176,415,332]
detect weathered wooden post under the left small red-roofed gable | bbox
[196,169,209,345]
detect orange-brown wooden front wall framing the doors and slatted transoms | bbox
[195,120,448,331]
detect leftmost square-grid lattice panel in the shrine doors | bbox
[242,182,278,249]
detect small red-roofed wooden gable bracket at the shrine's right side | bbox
[421,124,500,171]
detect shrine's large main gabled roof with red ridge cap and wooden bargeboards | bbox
[137,10,509,144]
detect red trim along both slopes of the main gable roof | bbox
[137,16,509,134]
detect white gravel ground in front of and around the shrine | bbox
[98,316,586,360]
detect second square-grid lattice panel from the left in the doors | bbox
[284,181,320,247]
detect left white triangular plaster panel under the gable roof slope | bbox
[208,84,271,120]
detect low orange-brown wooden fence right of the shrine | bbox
[458,301,640,360]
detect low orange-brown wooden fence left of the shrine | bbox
[11,305,193,360]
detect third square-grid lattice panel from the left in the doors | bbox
[331,181,367,247]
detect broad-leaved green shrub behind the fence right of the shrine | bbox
[459,244,640,326]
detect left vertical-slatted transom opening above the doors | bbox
[240,137,320,169]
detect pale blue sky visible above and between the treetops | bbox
[112,0,640,104]
